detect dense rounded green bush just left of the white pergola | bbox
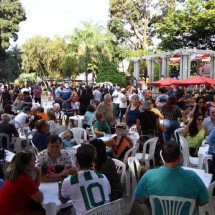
[96,64,126,86]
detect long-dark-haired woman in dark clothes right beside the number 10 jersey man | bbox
[90,139,122,201]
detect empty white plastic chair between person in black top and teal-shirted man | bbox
[135,137,158,169]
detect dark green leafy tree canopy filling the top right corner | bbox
[157,0,215,50]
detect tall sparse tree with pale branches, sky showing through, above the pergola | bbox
[108,0,175,50]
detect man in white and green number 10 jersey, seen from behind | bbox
[59,144,111,215]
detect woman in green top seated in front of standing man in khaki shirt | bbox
[93,112,111,137]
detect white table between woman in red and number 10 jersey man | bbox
[39,182,72,215]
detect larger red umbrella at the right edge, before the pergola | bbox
[181,76,215,85]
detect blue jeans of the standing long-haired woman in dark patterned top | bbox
[163,119,180,142]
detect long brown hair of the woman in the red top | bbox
[5,152,33,181]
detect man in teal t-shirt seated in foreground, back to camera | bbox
[135,141,209,214]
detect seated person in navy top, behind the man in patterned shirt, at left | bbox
[32,119,49,152]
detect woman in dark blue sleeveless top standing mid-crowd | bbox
[125,95,141,128]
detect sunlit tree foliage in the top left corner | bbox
[0,0,26,51]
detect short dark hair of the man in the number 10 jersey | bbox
[76,144,94,168]
